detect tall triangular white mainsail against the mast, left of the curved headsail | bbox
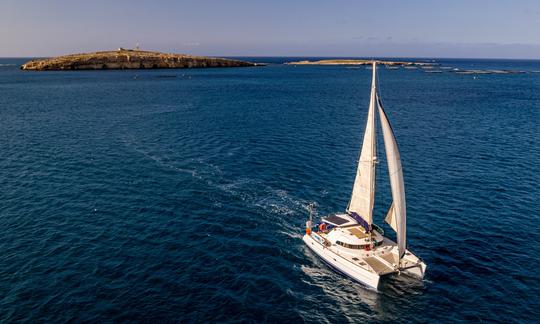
[347,62,377,226]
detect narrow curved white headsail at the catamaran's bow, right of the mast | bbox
[377,98,407,259]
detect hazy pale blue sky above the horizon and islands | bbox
[0,0,540,59]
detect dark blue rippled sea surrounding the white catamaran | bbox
[0,58,540,323]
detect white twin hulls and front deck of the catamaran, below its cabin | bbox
[302,233,426,290]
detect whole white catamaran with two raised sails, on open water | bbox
[303,62,426,289]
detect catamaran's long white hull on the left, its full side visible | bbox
[302,234,380,290]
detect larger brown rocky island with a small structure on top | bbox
[21,48,263,71]
